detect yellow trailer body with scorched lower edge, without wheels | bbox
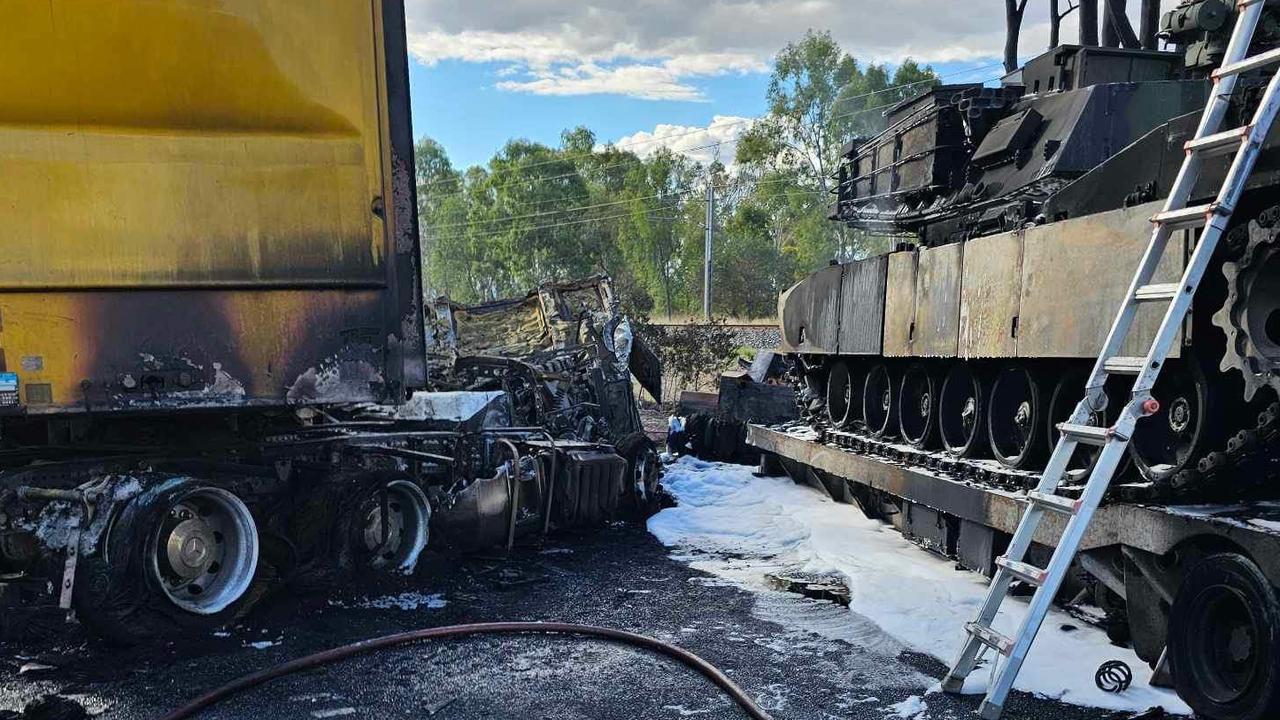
[0,0,422,414]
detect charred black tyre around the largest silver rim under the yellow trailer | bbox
[72,479,263,646]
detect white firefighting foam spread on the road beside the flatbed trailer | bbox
[649,457,1190,715]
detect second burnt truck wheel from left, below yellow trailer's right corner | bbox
[338,473,431,574]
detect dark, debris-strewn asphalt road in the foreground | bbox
[0,525,1126,720]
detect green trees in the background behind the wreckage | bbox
[416,32,937,318]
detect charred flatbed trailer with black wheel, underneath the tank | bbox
[746,424,1280,720]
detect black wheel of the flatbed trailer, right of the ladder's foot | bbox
[1169,552,1280,720]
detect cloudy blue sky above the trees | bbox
[406,0,1175,167]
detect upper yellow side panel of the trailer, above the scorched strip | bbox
[0,0,385,288]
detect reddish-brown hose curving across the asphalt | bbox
[163,623,772,720]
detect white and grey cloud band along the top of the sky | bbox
[407,0,1176,101]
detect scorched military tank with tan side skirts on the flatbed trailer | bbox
[780,0,1280,500]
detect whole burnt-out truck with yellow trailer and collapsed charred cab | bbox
[0,0,660,642]
